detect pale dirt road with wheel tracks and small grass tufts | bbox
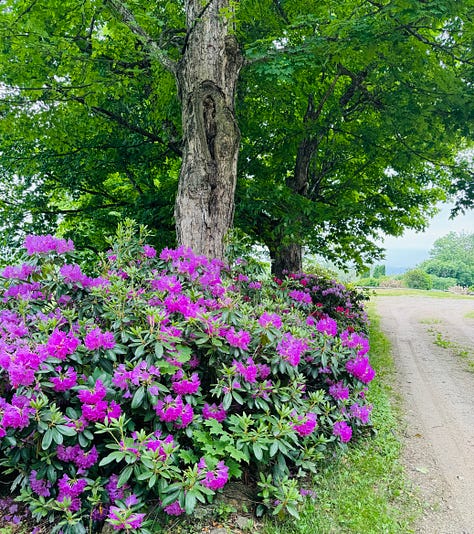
[375,296,474,534]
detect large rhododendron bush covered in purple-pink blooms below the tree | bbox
[0,222,374,533]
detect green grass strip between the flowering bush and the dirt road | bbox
[263,307,421,534]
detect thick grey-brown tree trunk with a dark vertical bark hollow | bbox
[175,0,243,258]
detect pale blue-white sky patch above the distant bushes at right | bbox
[382,205,474,274]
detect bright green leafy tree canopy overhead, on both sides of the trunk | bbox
[0,0,473,263]
